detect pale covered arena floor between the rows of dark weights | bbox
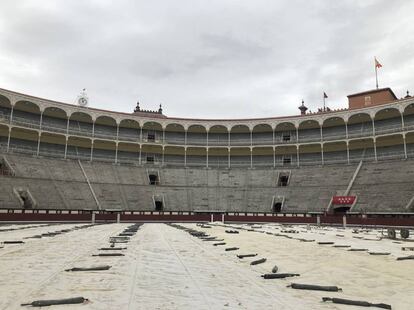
[0,223,414,310]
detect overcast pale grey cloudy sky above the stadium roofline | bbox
[0,0,414,118]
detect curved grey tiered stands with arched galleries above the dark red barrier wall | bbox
[0,88,414,223]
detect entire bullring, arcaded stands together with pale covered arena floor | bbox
[0,88,414,309]
